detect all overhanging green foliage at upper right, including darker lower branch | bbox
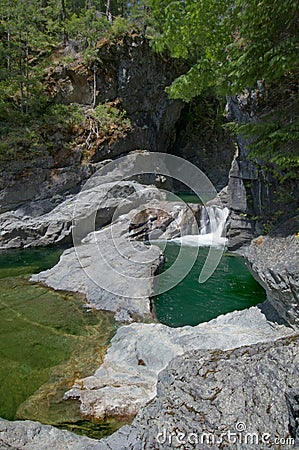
[152,0,299,180]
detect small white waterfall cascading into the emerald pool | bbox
[171,206,229,247]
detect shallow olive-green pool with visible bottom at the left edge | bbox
[0,248,121,438]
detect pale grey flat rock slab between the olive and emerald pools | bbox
[31,222,163,321]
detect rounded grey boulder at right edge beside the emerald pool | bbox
[246,229,299,327]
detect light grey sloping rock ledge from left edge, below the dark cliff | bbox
[0,179,161,248]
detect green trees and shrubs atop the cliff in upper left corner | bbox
[0,0,155,116]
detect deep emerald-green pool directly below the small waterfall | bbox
[154,244,266,327]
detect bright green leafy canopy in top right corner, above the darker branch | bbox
[152,0,299,97]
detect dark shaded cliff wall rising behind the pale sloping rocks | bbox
[0,35,234,224]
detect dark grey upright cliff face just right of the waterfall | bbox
[227,92,298,250]
